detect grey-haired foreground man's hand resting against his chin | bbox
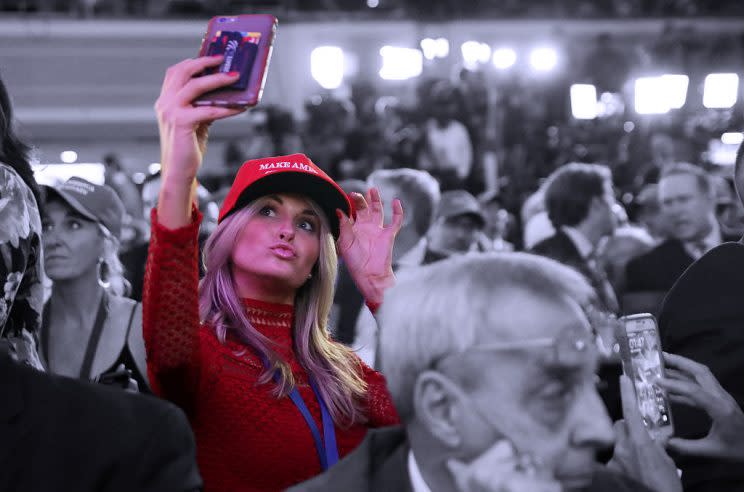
[447,439,562,492]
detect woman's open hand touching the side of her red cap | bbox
[336,188,403,304]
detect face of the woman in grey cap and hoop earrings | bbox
[42,200,103,282]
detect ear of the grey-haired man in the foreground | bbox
[413,371,462,448]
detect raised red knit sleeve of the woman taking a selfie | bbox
[142,207,202,413]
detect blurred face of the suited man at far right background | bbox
[659,174,714,241]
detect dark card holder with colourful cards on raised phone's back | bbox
[206,31,261,90]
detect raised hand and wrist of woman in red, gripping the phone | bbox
[155,55,245,228]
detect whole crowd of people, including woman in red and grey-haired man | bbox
[0,25,744,492]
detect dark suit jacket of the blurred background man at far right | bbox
[625,239,695,292]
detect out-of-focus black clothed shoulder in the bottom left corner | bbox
[0,354,202,492]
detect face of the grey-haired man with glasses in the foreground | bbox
[435,289,614,490]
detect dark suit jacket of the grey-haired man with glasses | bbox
[288,427,650,492]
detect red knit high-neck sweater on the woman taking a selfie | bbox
[143,210,398,492]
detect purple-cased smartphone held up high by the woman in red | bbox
[194,14,279,107]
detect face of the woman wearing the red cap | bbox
[231,193,321,296]
